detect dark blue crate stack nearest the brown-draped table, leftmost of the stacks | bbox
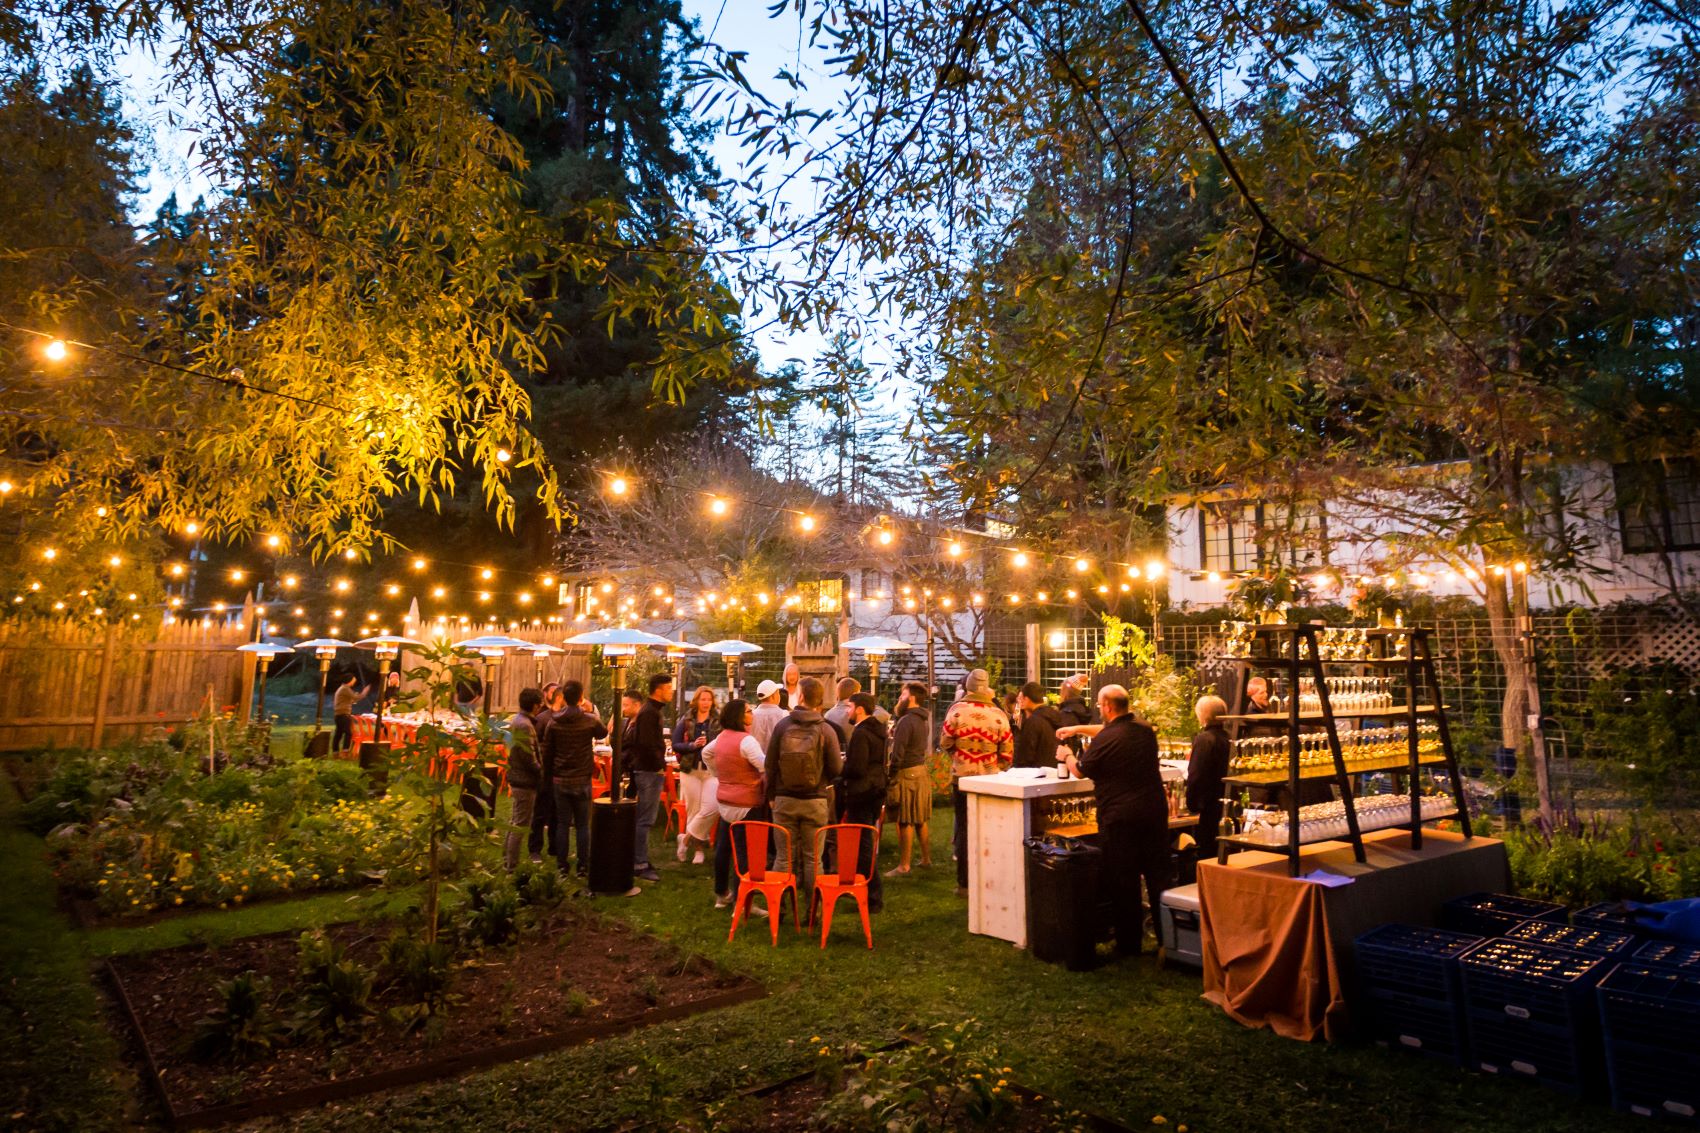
[1357,924,1482,1067]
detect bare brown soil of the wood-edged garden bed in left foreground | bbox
[109,907,765,1126]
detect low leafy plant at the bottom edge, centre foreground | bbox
[809,1019,1088,1133]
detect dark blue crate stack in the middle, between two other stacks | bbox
[1459,939,1612,1096]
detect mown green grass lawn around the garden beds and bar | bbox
[0,783,1647,1133]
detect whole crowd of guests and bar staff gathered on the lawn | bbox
[489,665,1229,953]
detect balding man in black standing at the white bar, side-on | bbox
[1068,684,1168,956]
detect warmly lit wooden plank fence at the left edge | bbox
[0,621,253,752]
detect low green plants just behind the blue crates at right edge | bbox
[1505,811,1700,905]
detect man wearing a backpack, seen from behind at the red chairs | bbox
[767,677,843,915]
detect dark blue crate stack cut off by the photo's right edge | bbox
[1598,944,1700,1121]
